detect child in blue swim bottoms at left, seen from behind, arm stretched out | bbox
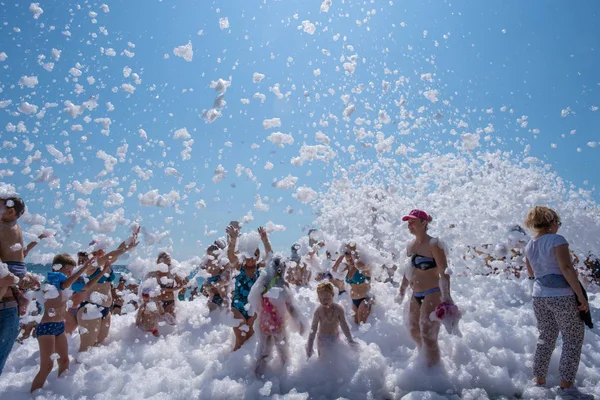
[31,254,93,392]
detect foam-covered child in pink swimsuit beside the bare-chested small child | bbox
[248,257,304,376]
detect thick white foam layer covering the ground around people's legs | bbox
[0,276,600,400]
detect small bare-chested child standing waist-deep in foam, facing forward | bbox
[306,282,356,357]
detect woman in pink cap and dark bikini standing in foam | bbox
[400,210,454,366]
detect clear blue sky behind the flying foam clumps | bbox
[0,0,600,258]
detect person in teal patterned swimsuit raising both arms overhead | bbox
[226,224,273,351]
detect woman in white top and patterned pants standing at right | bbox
[525,206,593,399]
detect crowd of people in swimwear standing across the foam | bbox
[0,197,595,398]
